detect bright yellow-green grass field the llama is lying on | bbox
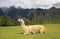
[0,24,60,39]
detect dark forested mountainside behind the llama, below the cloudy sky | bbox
[0,6,60,25]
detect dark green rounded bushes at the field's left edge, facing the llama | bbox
[0,16,16,26]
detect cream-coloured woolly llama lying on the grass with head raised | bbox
[18,18,45,34]
